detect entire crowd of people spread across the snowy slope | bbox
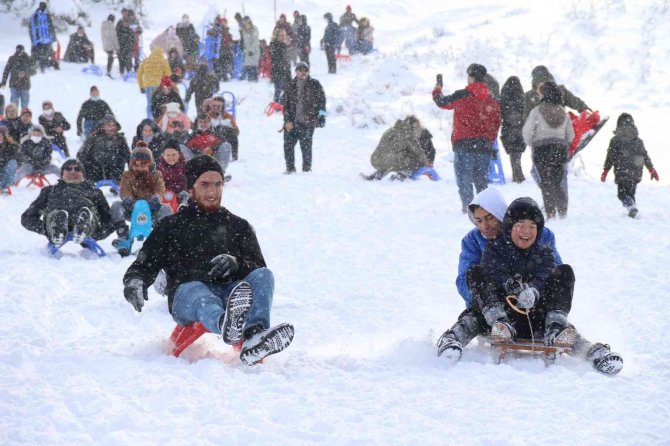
[0,4,658,373]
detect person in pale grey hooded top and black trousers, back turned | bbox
[522,82,575,219]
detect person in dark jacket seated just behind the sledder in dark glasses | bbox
[77,115,130,184]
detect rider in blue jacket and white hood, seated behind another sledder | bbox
[437,193,621,373]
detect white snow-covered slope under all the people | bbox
[0,0,670,446]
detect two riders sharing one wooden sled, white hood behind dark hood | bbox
[437,188,623,374]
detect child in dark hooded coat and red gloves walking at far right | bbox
[600,113,658,218]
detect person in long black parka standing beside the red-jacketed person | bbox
[500,76,526,183]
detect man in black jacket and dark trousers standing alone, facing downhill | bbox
[282,62,326,174]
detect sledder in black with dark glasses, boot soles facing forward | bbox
[21,159,128,247]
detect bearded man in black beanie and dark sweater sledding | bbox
[123,155,294,365]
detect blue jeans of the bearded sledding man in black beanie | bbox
[172,268,275,334]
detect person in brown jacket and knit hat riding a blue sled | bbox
[112,141,172,244]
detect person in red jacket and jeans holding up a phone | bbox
[433,63,500,214]
